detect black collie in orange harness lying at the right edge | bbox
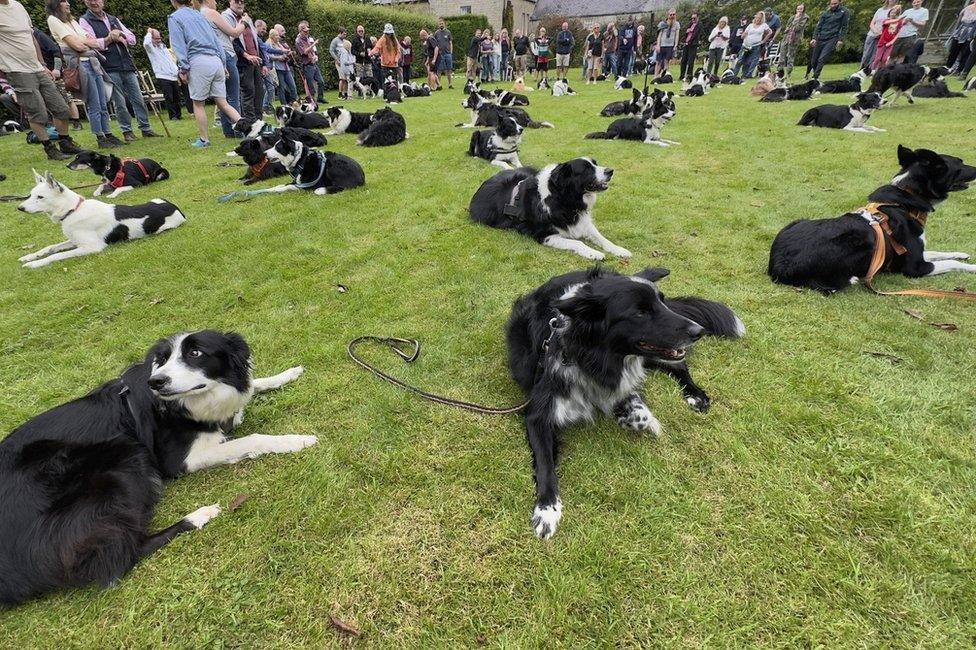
[767,146,976,293]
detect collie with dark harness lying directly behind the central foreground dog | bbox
[468,158,630,260]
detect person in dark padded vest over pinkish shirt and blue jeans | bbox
[78,0,159,142]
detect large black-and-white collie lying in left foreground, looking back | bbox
[0,331,316,604]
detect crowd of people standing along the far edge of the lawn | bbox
[0,0,976,159]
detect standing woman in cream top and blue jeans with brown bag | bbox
[46,0,124,147]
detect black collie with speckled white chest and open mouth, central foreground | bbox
[506,268,745,539]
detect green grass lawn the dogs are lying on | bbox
[0,66,976,648]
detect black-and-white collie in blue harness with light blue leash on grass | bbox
[267,131,366,196]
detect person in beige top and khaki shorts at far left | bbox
[0,0,81,160]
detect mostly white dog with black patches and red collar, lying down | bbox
[17,171,186,269]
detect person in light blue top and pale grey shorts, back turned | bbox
[167,0,241,148]
